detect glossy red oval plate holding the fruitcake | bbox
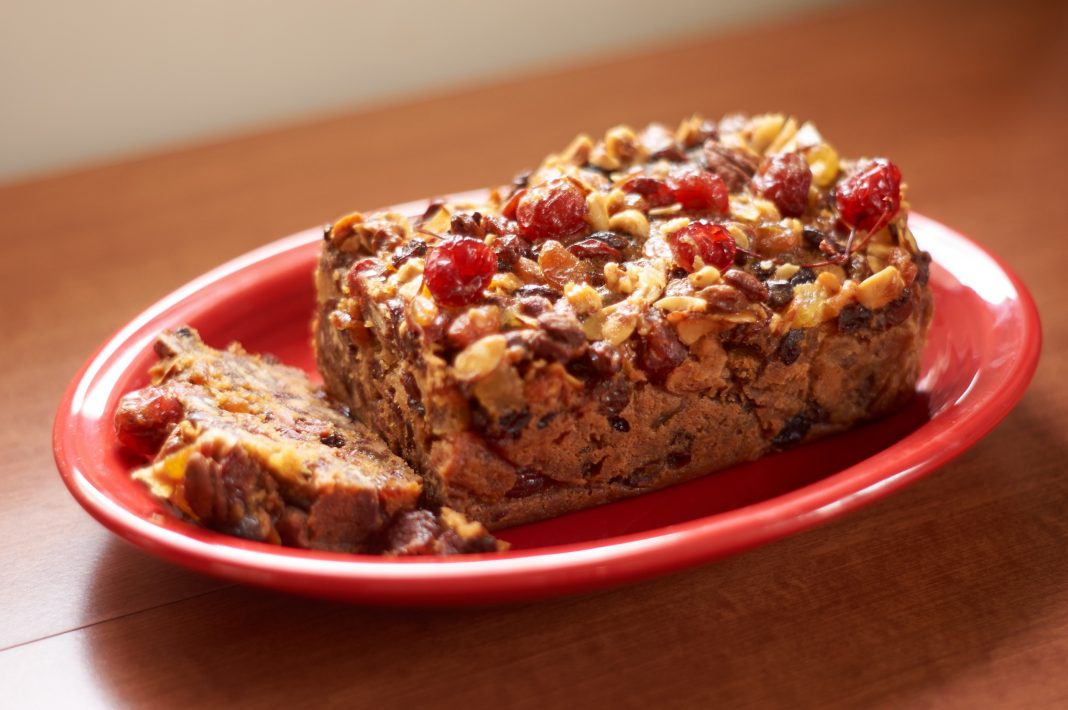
[53,203,1041,605]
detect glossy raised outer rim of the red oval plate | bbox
[52,208,1042,605]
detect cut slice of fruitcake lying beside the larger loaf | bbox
[115,328,501,555]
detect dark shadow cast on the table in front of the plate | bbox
[87,399,1068,708]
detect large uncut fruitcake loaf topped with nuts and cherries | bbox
[314,115,931,528]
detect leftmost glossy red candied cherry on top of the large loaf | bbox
[423,237,497,306]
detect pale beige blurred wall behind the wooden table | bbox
[0,0,841,182]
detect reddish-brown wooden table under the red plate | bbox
[0,1,1068,708]
